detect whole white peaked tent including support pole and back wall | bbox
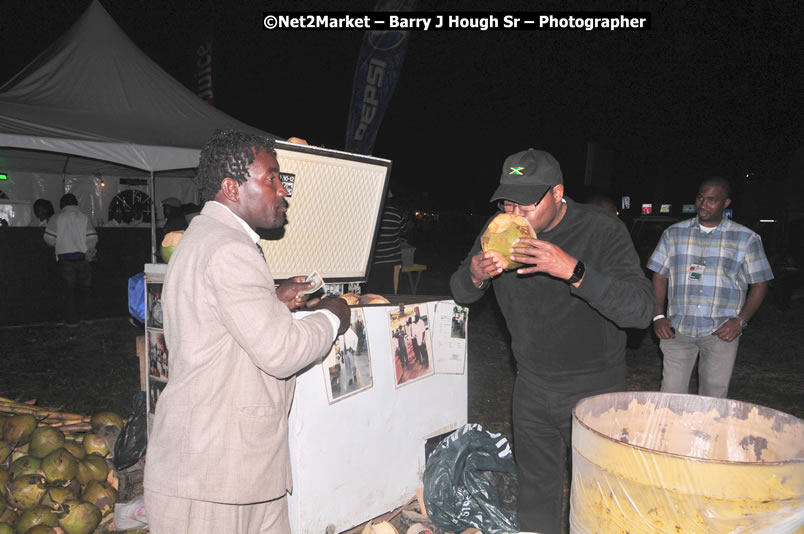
[0,0,277,261]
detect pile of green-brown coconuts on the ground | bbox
[0,397,123,534]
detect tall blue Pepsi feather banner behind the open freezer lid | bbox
[345,0,416,154]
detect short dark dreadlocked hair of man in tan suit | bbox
[196,130,276,201]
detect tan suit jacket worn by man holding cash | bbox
[145,203,334,504]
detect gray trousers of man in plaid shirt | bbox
[659,334,740,398]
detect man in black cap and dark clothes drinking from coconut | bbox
[450,149,654,534]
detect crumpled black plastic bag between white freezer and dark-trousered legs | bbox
[424,425,519,534]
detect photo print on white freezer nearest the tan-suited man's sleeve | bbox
[322,308,374,404]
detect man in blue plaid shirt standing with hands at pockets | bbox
[647,177,773,397]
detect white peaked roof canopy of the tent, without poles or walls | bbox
[0,0,276,172]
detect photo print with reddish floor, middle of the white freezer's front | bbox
[388,303,433,387]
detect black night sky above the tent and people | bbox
[0,0,804,216]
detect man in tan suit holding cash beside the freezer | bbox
[145,131,350,534]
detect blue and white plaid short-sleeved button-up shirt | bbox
[647,217,773,337]
